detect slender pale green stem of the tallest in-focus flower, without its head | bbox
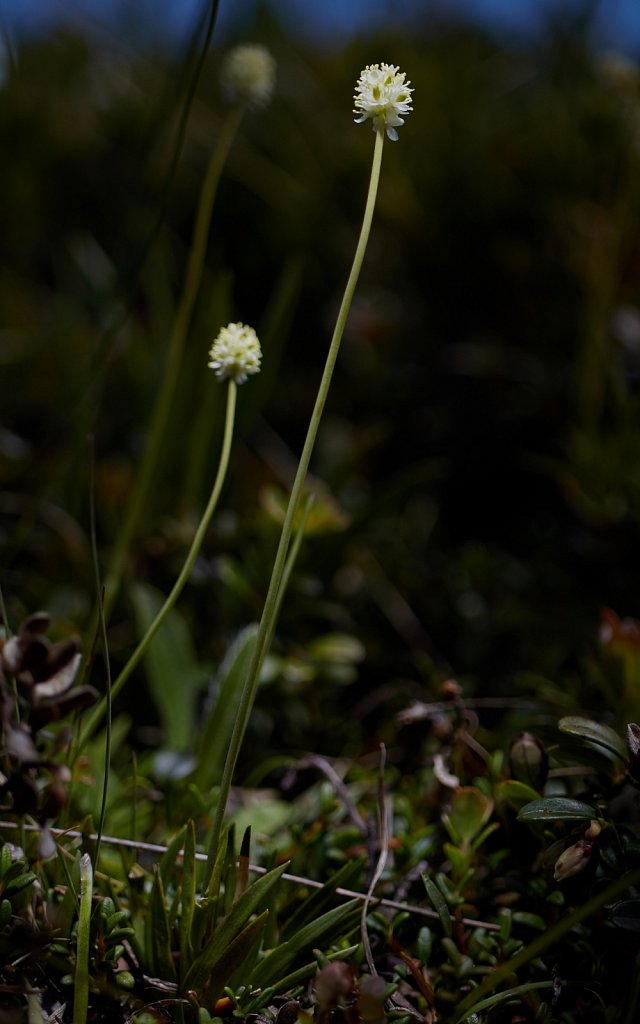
[205,125,384,884]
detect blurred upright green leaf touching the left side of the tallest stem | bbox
[194,625,258,792]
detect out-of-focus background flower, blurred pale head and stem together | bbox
[104,46,275,621]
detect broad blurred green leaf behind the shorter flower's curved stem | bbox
[131,584,210,751]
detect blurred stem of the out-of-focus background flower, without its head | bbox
[104,106,244,621]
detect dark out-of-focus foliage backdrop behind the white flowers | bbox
[0,2,640,767]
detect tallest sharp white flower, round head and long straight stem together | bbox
[204,65,413,886]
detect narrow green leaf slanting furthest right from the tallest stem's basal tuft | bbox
[246,899,362,988]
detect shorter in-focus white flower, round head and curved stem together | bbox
[80,324,262,746]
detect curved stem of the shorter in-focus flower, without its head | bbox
[80,380,238,746]
